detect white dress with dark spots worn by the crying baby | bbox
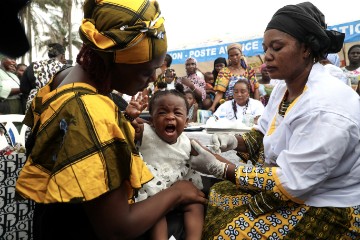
[136,123,203,201]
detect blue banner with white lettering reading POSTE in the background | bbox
[168,20,360,64]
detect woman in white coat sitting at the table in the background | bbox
[214,79,264,124]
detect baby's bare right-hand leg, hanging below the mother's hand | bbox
[183,203,204,240]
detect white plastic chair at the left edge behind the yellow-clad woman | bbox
[0,114,27,149]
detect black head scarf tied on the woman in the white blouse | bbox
[265,2,345,55]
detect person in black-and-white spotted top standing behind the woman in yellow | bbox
[20,43,66,111]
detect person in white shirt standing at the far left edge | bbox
[0,57,24,114]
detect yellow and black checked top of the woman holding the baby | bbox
[16,83,153,203]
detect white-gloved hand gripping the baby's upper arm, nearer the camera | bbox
[190,140,226,179]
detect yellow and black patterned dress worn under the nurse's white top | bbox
[203,130,360,240]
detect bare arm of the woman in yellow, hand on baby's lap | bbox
[84,181,206,239]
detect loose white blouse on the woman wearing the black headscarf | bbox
[256,63,360,207]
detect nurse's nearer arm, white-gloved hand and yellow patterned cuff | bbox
[190,140,290,215]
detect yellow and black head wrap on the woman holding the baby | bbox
[79,0,167,64]
